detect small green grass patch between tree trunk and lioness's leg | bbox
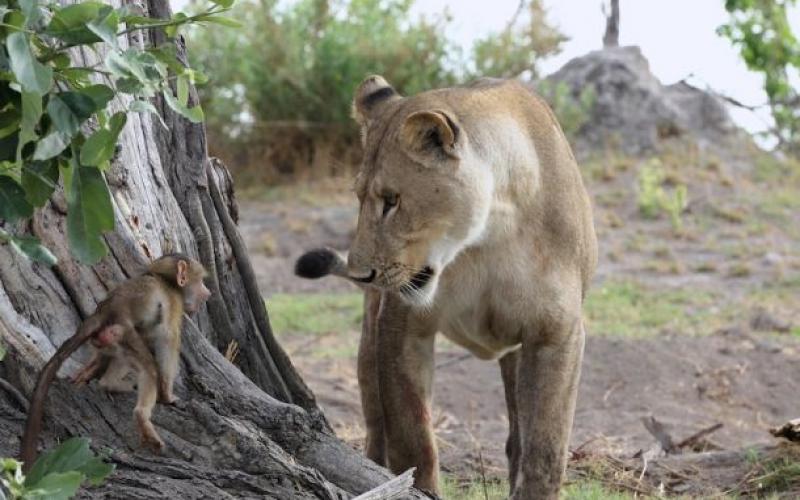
[266,293,364,335]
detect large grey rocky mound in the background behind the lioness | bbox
[547,47,744,154]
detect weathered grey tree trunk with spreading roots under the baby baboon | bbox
[0,0,423,499]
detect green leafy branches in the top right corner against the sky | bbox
[718,0,800,155]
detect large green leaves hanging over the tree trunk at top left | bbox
[0,0,233,264]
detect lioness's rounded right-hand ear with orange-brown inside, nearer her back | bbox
[400,110,460,159]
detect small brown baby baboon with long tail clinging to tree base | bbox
[20,254,210,470]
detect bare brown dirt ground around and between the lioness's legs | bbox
[234,147,800,492]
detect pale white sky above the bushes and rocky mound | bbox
[175,0,800,137]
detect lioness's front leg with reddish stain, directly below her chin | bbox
[377,293,439,493]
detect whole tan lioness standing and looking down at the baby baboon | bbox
[297,76,597,499]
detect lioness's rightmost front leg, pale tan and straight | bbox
[511,319,585,500]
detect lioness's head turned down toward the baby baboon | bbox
[348,76,493,306]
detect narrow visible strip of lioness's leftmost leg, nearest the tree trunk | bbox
[358,290,386,467]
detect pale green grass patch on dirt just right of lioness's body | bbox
[584,281,714,337]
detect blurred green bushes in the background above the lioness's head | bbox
[189,0,564,138]
